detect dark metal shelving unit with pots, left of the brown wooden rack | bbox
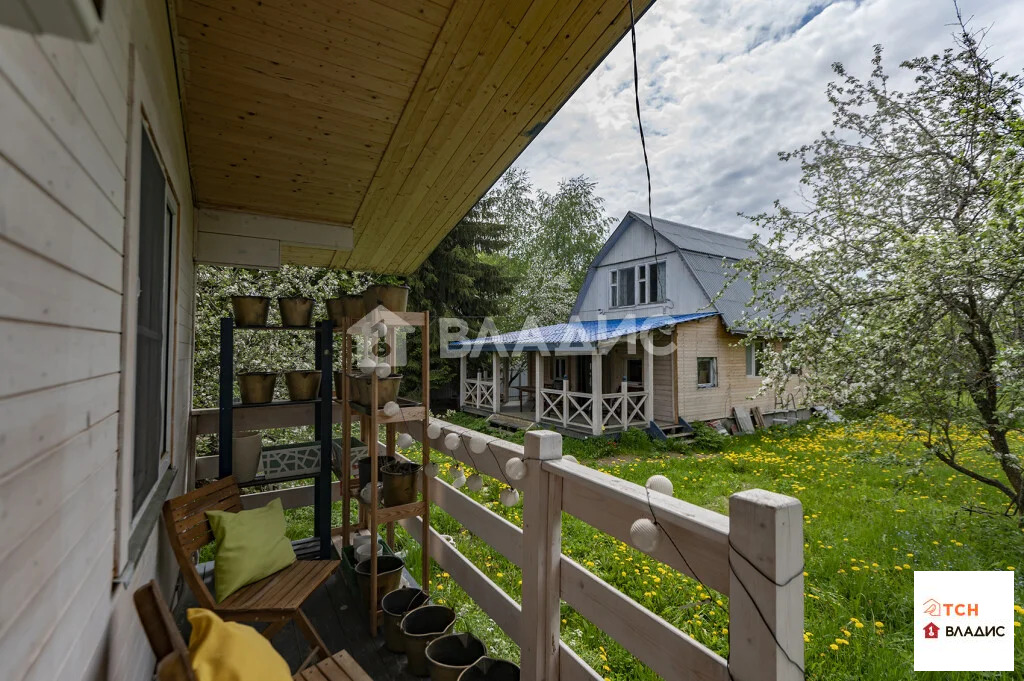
[218,316,335,559]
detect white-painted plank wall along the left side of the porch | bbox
[0,0,194,681]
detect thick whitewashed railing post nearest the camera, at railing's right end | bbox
[729,490,804,681]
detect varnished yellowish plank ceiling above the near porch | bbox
[170,0,652,273]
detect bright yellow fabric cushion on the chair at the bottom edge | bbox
[188,607,292,681]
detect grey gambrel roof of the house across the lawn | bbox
[571,211,755,333]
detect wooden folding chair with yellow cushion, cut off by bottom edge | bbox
[134,582,373,681]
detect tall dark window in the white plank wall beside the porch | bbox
[132,132,174,515]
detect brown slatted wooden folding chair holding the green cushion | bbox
[163,475,341,667]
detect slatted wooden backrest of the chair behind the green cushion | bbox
[163,475,242,609]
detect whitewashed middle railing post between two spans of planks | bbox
[519,430,562,681]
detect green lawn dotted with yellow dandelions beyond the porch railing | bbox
[282,414,1024,681]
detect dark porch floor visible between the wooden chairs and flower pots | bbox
[174,563,422,681]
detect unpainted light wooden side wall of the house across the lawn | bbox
[676,316,775,421]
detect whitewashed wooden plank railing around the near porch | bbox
[191,408,804,681]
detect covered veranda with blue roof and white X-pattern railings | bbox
[449,312,715,435]
